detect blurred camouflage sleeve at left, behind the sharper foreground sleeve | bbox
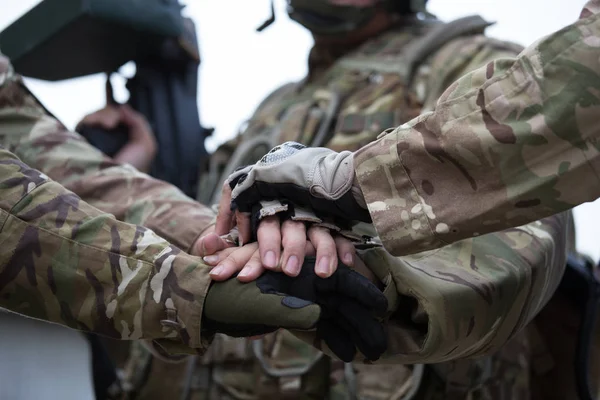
[0,69,214,251]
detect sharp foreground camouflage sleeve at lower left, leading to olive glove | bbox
[0,147,210,353]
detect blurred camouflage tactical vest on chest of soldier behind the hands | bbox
[197,16,490,205]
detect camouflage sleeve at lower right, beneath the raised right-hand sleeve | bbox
[354,212,572,364]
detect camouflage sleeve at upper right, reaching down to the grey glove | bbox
[354,0,600,255]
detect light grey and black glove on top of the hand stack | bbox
[229,142,371,222]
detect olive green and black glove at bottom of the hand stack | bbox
[202,257,387,362]
